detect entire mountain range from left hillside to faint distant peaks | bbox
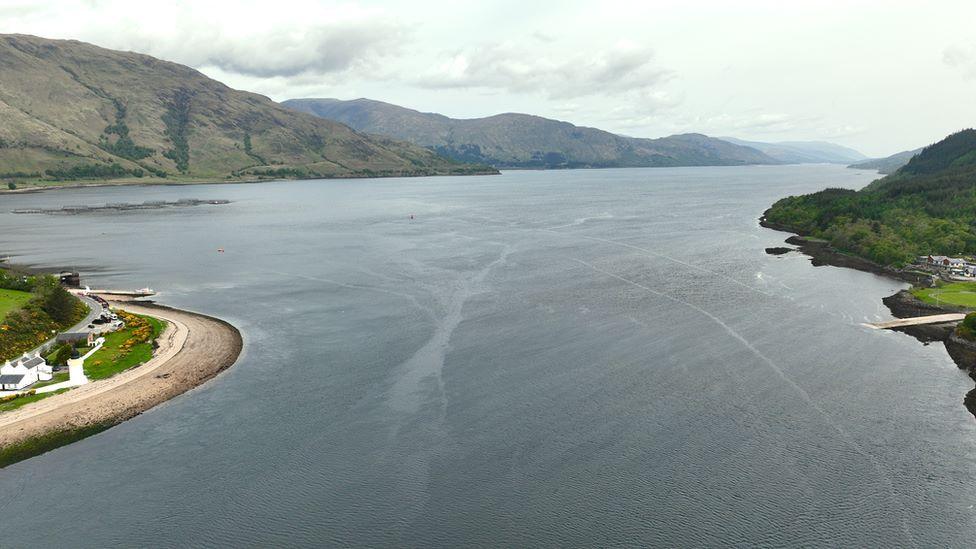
[0,34,880,186]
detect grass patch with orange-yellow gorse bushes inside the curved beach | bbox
[85,313,166,381]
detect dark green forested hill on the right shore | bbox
[764,129,976,265]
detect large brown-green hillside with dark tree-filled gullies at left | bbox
[0,35,492,187]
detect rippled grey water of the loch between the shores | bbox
[0,165,976,547]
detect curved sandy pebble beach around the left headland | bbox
[0,299,244,469]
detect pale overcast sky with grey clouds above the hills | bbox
[0,0,976,156]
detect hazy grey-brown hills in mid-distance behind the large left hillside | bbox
[283,99,779,168]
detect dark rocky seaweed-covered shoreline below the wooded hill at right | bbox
[759,213,976,418]
